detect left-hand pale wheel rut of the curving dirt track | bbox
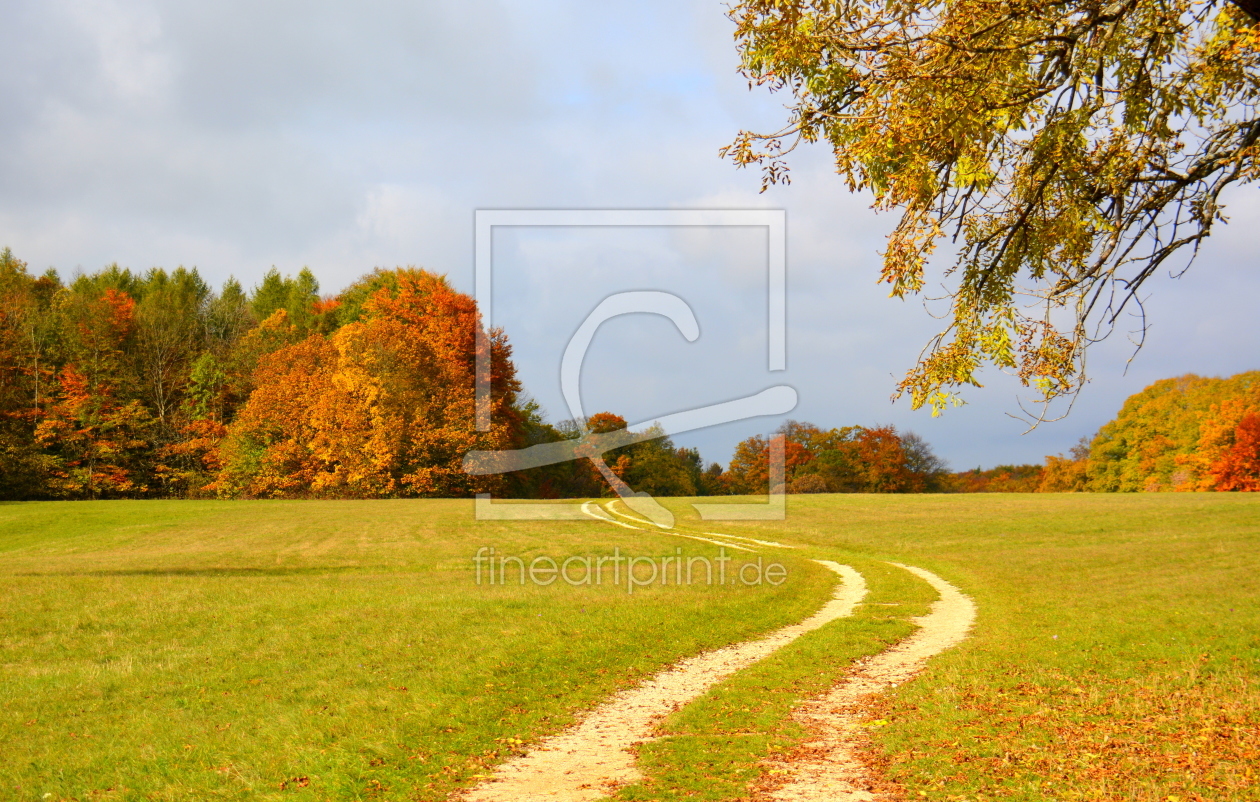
[462,560,866,802]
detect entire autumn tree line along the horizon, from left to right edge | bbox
[0,249,1260,500]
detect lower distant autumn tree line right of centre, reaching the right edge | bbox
[670,371,1260,494]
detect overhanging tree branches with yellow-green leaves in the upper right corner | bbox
[723,0,1260,417]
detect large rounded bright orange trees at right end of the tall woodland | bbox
[214,269,519,497]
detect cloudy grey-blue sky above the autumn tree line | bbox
[0,0,1260,470]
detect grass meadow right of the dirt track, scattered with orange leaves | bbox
[667,494,1260,802]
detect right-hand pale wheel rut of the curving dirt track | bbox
[757,563,975,802]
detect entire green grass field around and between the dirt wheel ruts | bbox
[0,495,1260,801]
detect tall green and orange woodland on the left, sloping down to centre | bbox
[0,249,745,500]
